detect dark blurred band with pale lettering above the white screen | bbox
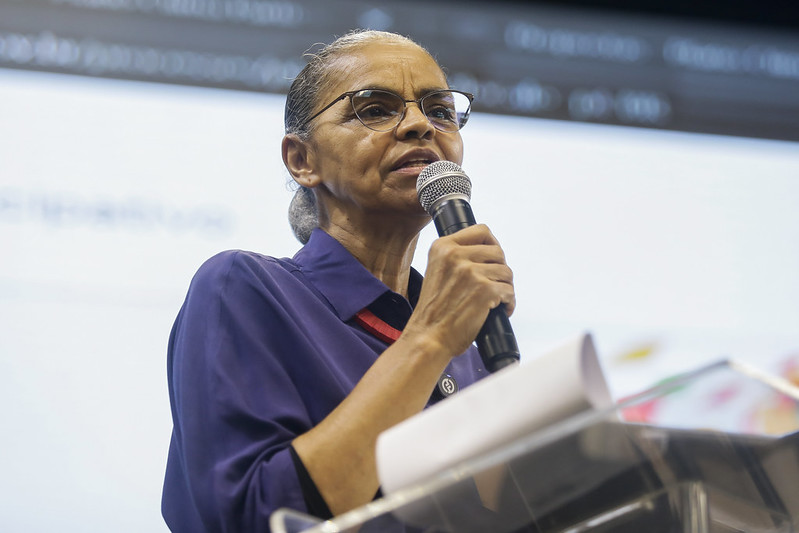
[0,0,799,141]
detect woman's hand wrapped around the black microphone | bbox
[403,224,516,357]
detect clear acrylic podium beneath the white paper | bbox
[271,361,799,533]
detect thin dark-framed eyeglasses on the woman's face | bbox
[308,89,474,132]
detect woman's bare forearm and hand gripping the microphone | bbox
[293,225,515,515]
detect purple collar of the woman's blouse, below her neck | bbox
[294,228,390,322]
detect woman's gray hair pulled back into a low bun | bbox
[283,30,434,244]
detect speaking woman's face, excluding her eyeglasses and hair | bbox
[302,42,463,231]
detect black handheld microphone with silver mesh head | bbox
[416,161,519,372]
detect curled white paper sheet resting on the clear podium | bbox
[376,334,613,494]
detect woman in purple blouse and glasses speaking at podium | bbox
[162,31,514,532]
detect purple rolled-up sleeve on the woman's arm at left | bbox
[163,252,320,531]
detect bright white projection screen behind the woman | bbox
[0,70,799,533]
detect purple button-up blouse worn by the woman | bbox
[162,229,487,533]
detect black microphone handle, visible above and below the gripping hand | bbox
[433,198,520,372]
